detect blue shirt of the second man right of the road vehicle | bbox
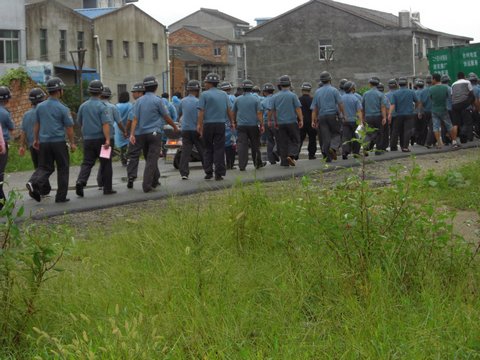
[198,87,230,124]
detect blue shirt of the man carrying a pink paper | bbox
[77,97,112,140]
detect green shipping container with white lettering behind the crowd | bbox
[427,43,480,80]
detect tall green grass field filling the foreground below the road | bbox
[0,156,480,359]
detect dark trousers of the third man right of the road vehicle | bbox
[237,125,262,170]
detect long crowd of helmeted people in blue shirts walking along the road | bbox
[0,71,480,203]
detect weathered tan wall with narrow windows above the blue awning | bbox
[26,0,96,68]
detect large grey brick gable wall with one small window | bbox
[245,2,413,88]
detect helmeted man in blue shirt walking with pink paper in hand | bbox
[75,80,116,197]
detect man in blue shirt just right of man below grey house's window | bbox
[342,81,363,160]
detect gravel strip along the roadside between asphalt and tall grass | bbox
[34,149,480,237]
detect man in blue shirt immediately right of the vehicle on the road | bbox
[178,80,203,180]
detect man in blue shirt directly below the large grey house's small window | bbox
[312,71,345,162]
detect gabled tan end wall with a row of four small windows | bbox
[92,5,168,96]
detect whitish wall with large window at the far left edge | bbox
[0,0,27,75]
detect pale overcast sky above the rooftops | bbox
[137,0,480,42]
